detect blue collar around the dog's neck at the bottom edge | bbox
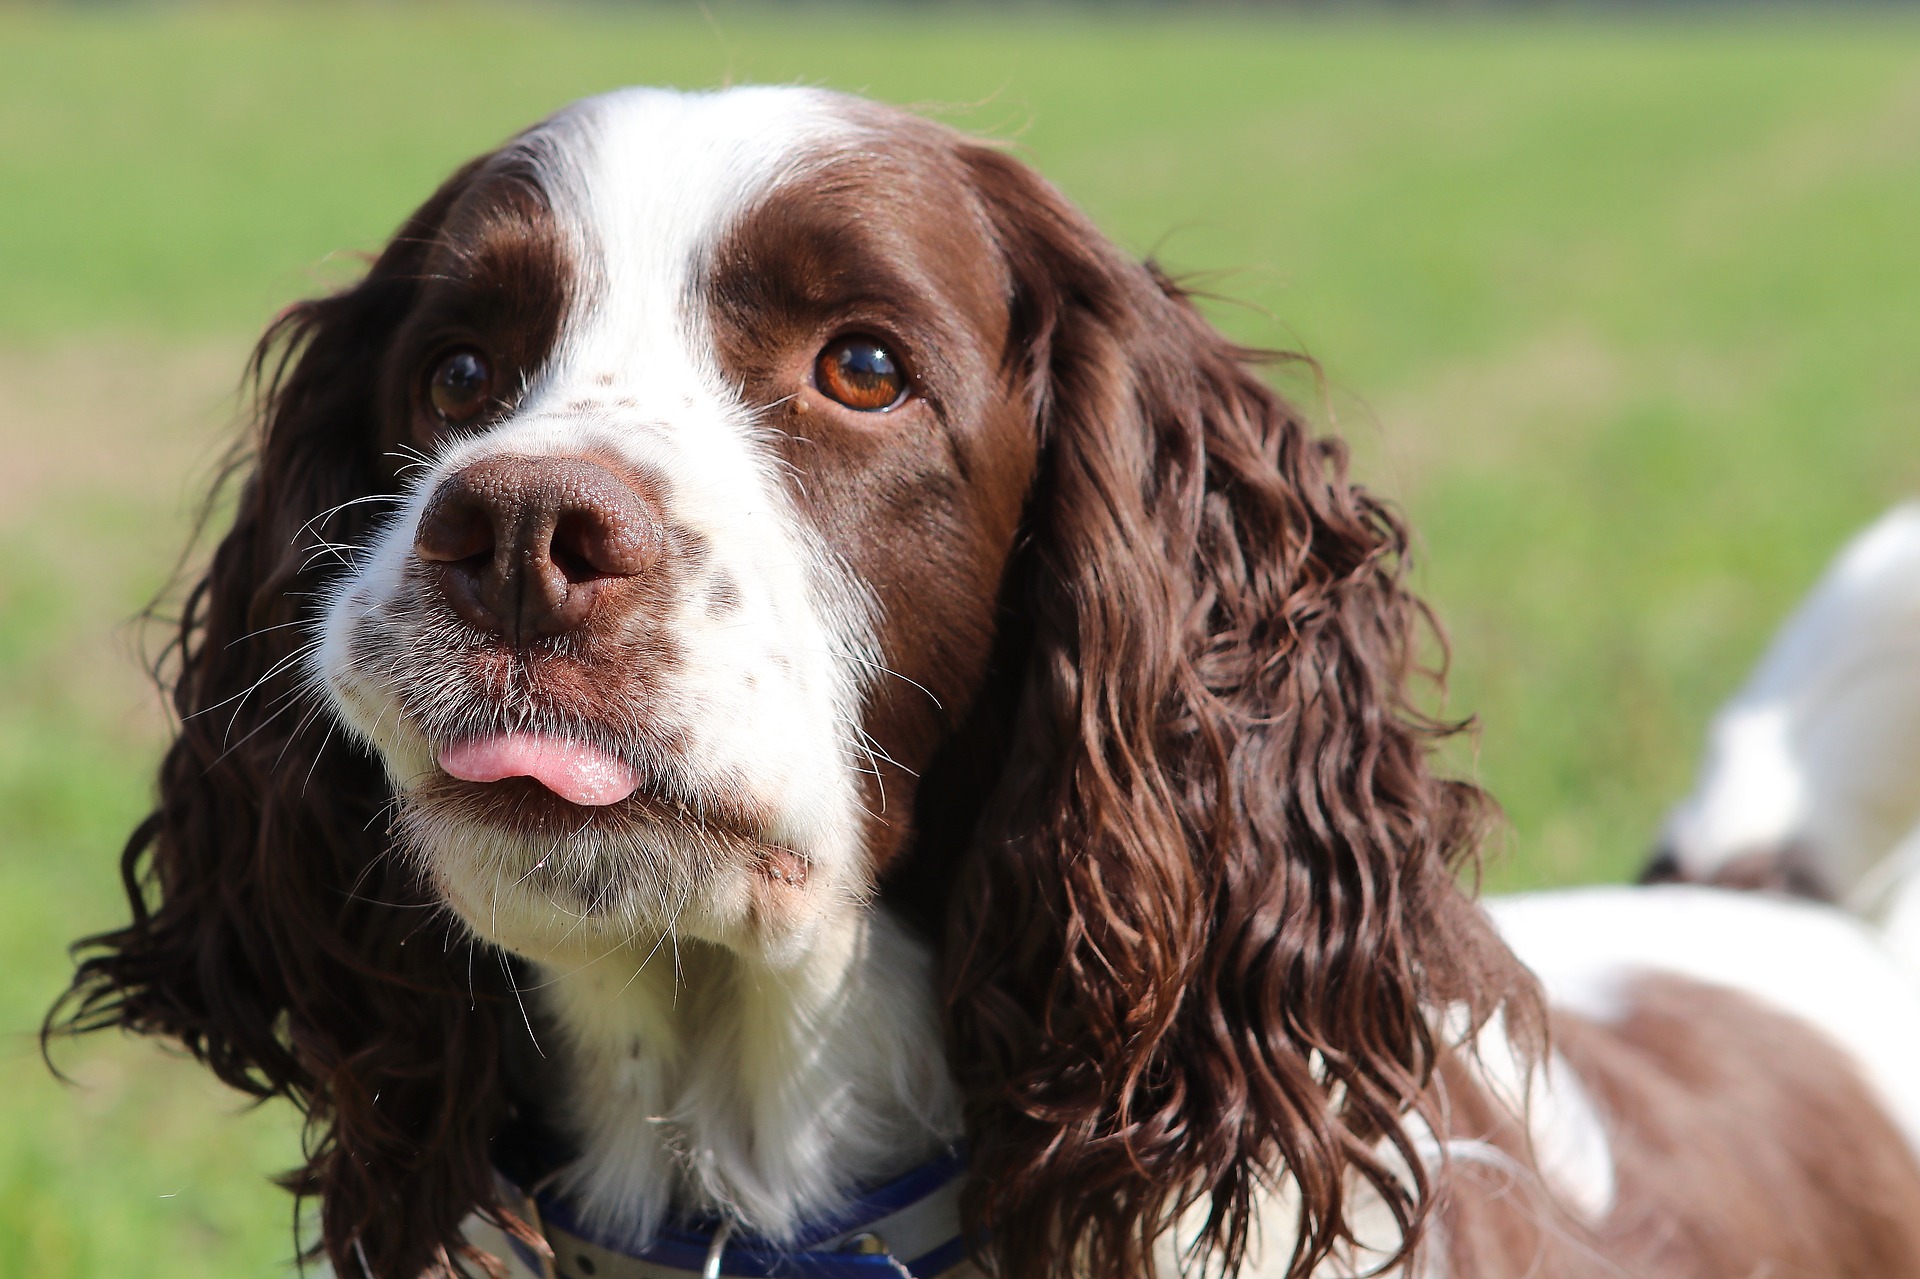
[513,1150,966,1279]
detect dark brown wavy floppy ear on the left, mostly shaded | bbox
[48,167,526,1279]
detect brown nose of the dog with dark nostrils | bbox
[413,457,660,645]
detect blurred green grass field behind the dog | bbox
[0,6,1920,1277]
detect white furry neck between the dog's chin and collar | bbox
[541,908,960,1244]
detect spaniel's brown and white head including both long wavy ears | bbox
[63,90,1515,1279]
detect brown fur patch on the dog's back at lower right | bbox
[1444,976,1920,1279]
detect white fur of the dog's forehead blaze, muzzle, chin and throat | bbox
[315,88,958,1243]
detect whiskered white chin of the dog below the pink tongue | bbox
[401,774,835,962]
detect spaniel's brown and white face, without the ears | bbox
[315,90,1037,956]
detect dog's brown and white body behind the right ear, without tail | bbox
[468,887,1920,1279]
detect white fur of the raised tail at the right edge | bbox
[1665,503,1920,894]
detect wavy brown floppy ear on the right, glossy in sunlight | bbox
[947,150,1528,1279]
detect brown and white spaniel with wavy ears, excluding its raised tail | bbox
[45,88,1920,1279]
